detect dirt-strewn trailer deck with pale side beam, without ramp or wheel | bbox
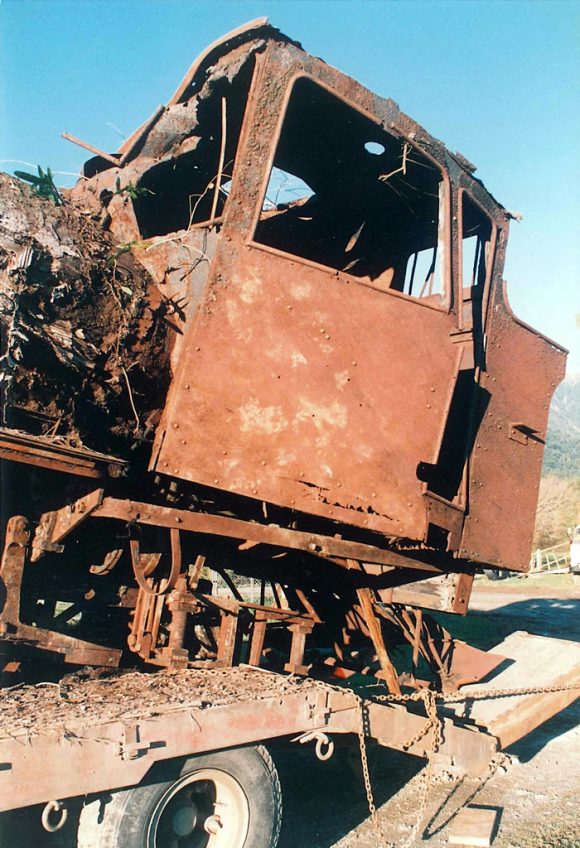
[0,668,497,812]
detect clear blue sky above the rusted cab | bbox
[0,0,580,374]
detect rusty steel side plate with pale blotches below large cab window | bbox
[157,246,457,538]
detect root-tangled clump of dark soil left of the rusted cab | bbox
[0,174,170,453]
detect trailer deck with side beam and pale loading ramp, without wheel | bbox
[0,632,580,812]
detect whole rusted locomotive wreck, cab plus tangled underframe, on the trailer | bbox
[0,19,565,694]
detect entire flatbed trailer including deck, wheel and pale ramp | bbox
[0,634,580,848]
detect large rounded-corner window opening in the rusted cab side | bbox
[254,77,444,301]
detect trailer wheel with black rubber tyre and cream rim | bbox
[77,746,282,848]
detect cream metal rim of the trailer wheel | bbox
[147,768,250,848]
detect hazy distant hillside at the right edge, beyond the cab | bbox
[542,377,580,477]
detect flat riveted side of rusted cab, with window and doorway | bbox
[143,32,564,570]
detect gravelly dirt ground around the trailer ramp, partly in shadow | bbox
[279,578,580,848]
